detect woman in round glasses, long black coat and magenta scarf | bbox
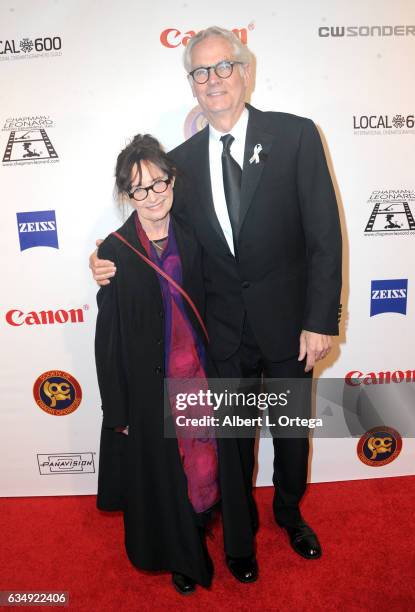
[95,135,219,594]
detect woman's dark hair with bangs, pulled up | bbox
[115,134,176,195]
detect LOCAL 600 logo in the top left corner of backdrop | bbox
[0,36,62,61]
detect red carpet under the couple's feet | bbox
[0,477,415,612]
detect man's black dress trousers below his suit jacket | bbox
[215,318,312,557]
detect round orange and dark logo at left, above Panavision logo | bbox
[33,370,82,416]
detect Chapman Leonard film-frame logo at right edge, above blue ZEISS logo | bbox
[365,189,415,236]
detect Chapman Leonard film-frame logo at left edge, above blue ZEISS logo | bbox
[2,115,59,166]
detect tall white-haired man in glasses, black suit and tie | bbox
[91,27,341,582]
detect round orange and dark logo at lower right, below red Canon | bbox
[357,426,402,467]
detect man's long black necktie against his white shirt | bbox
[221,134,242,244]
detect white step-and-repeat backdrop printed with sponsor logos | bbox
[0,0,415,496]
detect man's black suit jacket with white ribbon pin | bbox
[169,105,341,361]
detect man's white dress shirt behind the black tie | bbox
[209,108,249,255]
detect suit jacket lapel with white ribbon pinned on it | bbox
[239,105,274,231]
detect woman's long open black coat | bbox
[95,212,210,586]
